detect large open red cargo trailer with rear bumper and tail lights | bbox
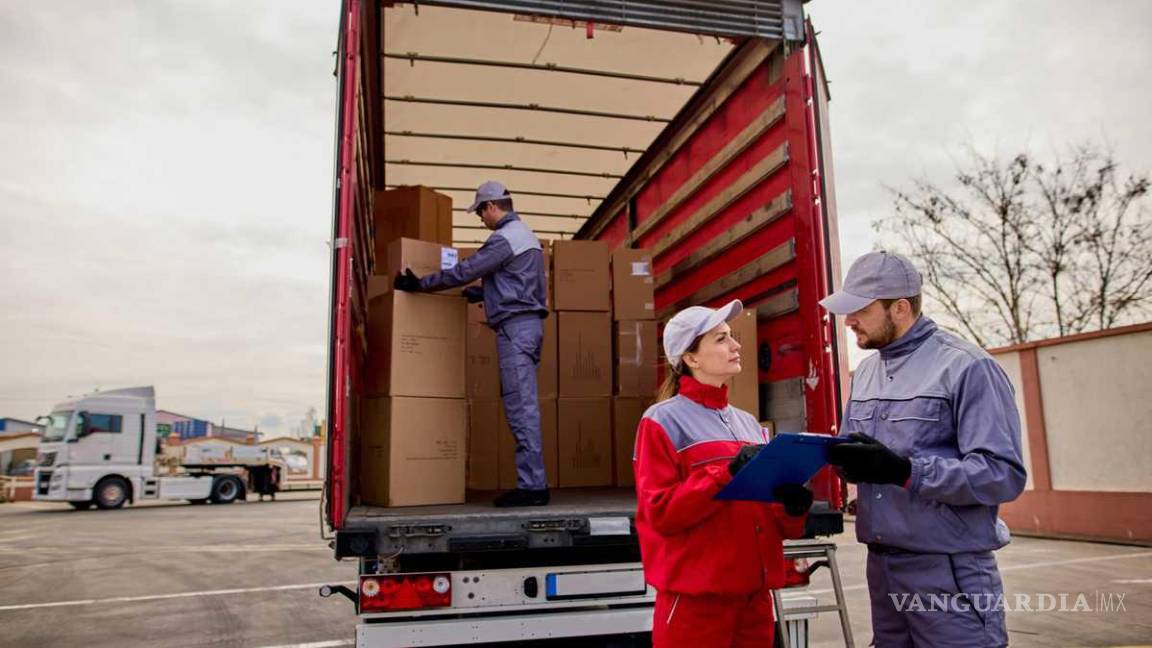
[320,0,850,646]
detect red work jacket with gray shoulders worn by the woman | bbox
[632,376,806,596]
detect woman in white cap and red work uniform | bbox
[632,301,812,648]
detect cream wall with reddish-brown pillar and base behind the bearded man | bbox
[991,323,1152,543]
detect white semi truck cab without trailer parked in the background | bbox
[32,387,281,510]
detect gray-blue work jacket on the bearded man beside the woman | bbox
[841,317,1026,553]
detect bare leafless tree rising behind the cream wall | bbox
[877,145,1152,346]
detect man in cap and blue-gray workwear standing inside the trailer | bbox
[395,181,548,507]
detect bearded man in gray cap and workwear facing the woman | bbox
[820,251,1026,648]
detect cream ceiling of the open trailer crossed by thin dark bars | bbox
[379,1,797,244]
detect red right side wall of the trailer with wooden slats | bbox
[578,18,843,509]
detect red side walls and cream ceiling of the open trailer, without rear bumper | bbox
[325,0,839,529]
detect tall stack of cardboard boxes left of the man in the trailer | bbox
[357,187,468,506]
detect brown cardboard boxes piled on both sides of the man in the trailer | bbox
[357,187,659,506]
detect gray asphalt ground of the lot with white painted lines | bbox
[0,493,1152,648]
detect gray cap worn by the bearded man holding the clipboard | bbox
[820,250,922,315]
